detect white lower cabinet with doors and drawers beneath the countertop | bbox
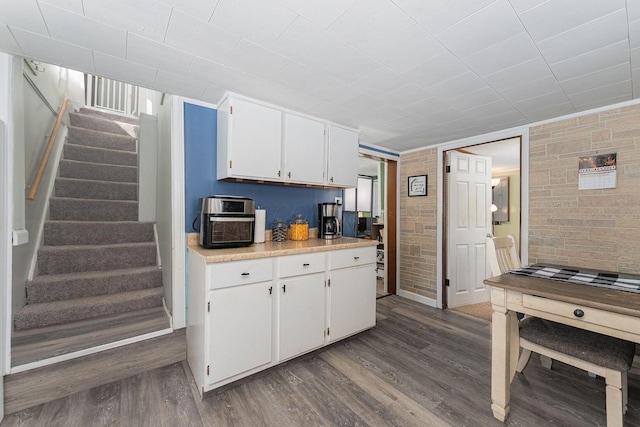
[187,246,376,393]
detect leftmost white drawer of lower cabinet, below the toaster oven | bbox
[211,258,273,289]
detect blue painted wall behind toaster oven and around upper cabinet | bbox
[184,103,342,233]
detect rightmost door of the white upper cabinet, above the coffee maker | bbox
[327,125,358,187]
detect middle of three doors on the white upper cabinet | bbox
[284,114,325,184]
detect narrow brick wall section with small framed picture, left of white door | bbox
[398,149,438,300]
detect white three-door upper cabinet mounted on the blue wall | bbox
[217,94,358,188]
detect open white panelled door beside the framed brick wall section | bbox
[446,151,491,307]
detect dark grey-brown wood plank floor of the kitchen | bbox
[0,296,640,427]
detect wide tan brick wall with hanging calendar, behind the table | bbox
[529,105,640,273]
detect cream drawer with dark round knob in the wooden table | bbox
[522,294,640,331]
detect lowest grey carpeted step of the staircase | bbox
[14,287,163,330]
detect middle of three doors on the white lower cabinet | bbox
[278,273,324,360]
